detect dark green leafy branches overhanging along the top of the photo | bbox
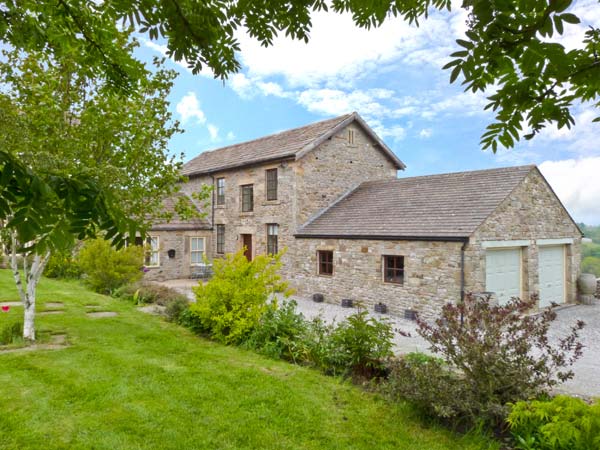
[0,0,600,151]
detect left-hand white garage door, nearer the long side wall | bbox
[485,248,521,305]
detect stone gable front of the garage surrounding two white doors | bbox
[465,169,581,302]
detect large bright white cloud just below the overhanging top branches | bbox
[238,8,467,88]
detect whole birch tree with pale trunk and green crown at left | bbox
[0,45,204,339]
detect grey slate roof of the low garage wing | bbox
[296,165,535,240]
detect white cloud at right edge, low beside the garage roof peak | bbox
[539,156,600,225]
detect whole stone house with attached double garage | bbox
[146,113,582,315]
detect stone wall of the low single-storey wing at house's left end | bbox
[144,230,213,280]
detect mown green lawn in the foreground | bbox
[0,270,497,450]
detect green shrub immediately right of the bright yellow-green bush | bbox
[245,300,307,363]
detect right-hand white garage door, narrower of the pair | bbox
[539,245,565,307]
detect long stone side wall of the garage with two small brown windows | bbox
[290,239,462,316]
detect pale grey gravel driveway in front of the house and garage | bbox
[161,280,600,397]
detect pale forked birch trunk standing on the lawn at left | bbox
[11,234,50,341]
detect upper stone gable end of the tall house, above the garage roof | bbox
[295,124,397,226]
